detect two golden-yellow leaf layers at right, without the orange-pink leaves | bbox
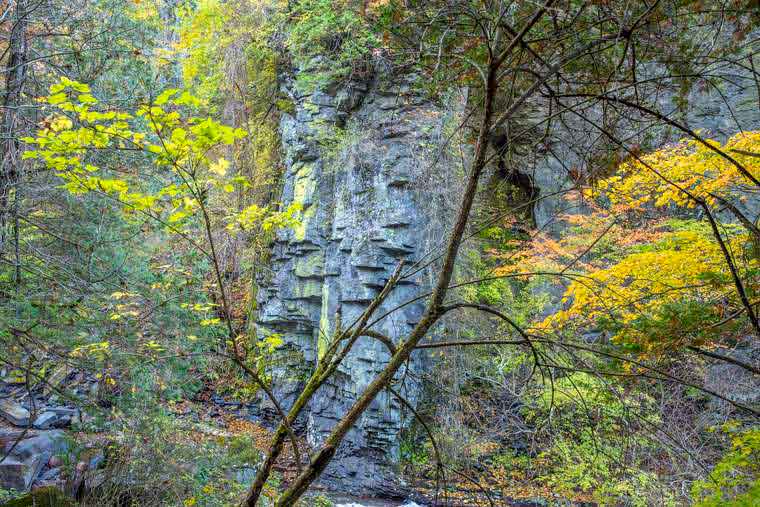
[528,131,760,352]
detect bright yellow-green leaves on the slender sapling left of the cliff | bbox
[23,78,295,245]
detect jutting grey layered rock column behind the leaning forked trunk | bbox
[258,66,456,491]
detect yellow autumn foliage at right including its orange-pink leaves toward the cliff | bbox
[497,132,760,353]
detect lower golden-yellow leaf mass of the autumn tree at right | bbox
[543,230,758,350]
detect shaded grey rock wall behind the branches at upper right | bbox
[525,31,760,228]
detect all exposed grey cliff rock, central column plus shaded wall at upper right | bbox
[257,25,760,492]
